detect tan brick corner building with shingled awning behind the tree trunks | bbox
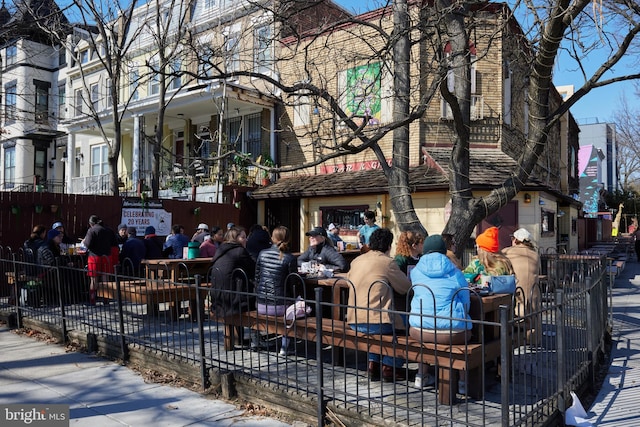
[252,1,579,252]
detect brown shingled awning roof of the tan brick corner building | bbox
[251,149,540,200]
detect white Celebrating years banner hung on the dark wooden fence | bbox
[121,199,172,236]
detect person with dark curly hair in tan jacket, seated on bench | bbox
[347,228,411,382]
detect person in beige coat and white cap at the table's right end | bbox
[502,228,542,344]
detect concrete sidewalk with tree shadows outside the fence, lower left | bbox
[0,326,306,427]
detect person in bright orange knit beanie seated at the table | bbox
[463,227,513,284]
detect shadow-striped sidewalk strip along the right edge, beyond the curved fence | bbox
[587,257,640,427]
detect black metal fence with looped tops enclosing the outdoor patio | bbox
[0,249,611,426]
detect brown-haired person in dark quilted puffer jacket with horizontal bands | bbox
[251,226,298,356]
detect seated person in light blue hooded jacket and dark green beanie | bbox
[409,234,472,394]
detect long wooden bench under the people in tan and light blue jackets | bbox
[224,311,501,405]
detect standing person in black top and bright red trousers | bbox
[83,215,118,305]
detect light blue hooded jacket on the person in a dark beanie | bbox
[409,252,472,331]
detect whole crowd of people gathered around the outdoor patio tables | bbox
[24,213,541,391]
